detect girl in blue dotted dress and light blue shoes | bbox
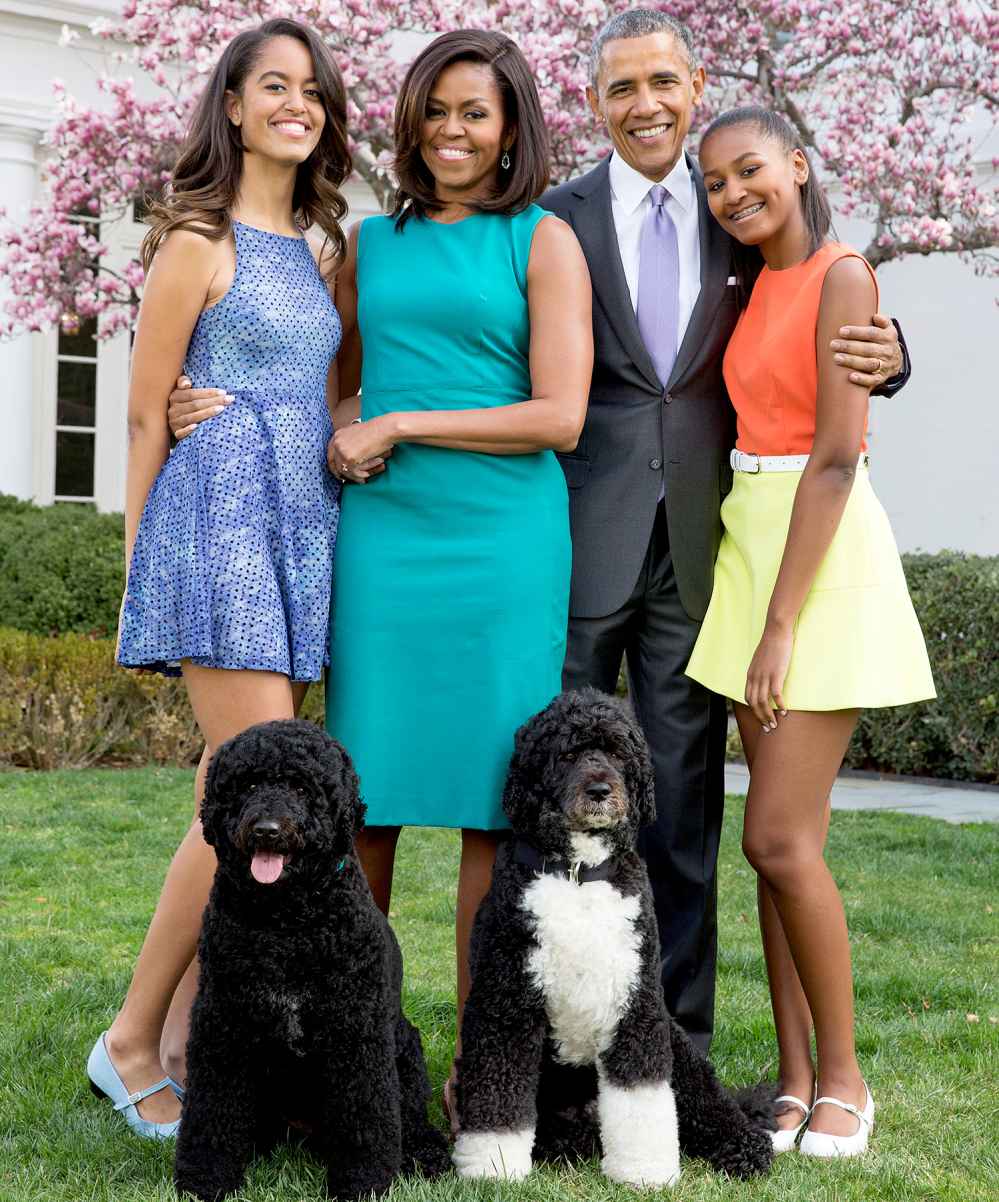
[88,20,351,1138]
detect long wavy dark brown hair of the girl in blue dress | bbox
[142,18,352,272]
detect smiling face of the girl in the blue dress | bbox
[226,37,326,166]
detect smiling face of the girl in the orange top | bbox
[700,124,808,260]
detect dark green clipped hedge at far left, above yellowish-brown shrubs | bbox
[0,496,125,636]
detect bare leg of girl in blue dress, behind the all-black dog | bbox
[100,661,308,1123]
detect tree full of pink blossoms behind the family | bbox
[0,0,999,337]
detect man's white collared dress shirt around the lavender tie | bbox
[609,154,701,349]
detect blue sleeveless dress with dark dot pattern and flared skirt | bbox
[118,221,340,680]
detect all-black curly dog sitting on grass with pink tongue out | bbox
[174,721,448,1200]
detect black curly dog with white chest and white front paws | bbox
[453,689,775,1188]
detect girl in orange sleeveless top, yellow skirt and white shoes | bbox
[688,108,934,1156]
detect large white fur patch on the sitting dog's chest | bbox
[522,875,641,1065]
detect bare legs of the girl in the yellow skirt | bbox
[736,706,866,1135]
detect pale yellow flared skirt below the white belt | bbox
[686,468,936,710]
